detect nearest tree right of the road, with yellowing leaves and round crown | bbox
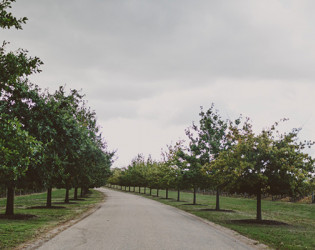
[217,119,315,221]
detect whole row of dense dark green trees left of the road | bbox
[0,0,114,215]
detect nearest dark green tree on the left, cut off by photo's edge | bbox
[0,0,42,214]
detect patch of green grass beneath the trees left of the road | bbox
[0,189,103,249]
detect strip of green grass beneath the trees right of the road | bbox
[116,188,315,249]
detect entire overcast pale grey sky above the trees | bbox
[0,0,315,167]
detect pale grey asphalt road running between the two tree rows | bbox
[39,188,260,250]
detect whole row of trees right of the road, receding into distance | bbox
[109,105,315,220]
